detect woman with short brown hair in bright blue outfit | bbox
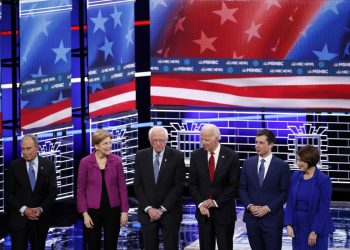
[284,145,334,250]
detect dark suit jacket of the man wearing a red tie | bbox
[188,146,239,224]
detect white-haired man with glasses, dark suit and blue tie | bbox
[134,126,185,250]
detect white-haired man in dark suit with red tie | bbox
[188,124,239,250]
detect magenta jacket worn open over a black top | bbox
[77,152,129,213]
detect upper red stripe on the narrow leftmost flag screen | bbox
[21,99,72,127]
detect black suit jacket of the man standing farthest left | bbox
[5,156,57,230]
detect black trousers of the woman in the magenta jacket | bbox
[84,207,120,250]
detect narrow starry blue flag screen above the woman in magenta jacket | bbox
[88,0,136,118]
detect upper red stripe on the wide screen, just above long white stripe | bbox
[151,77,350,99]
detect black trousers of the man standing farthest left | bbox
[10,221,49,250]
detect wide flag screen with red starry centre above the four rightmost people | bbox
[150,0,350,109]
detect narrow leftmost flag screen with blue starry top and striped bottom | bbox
[20,0,72,130]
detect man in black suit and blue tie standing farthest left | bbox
[5,135,57,250]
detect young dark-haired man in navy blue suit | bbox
[239,129,290,250]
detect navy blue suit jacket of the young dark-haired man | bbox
[239,156,290,227]
